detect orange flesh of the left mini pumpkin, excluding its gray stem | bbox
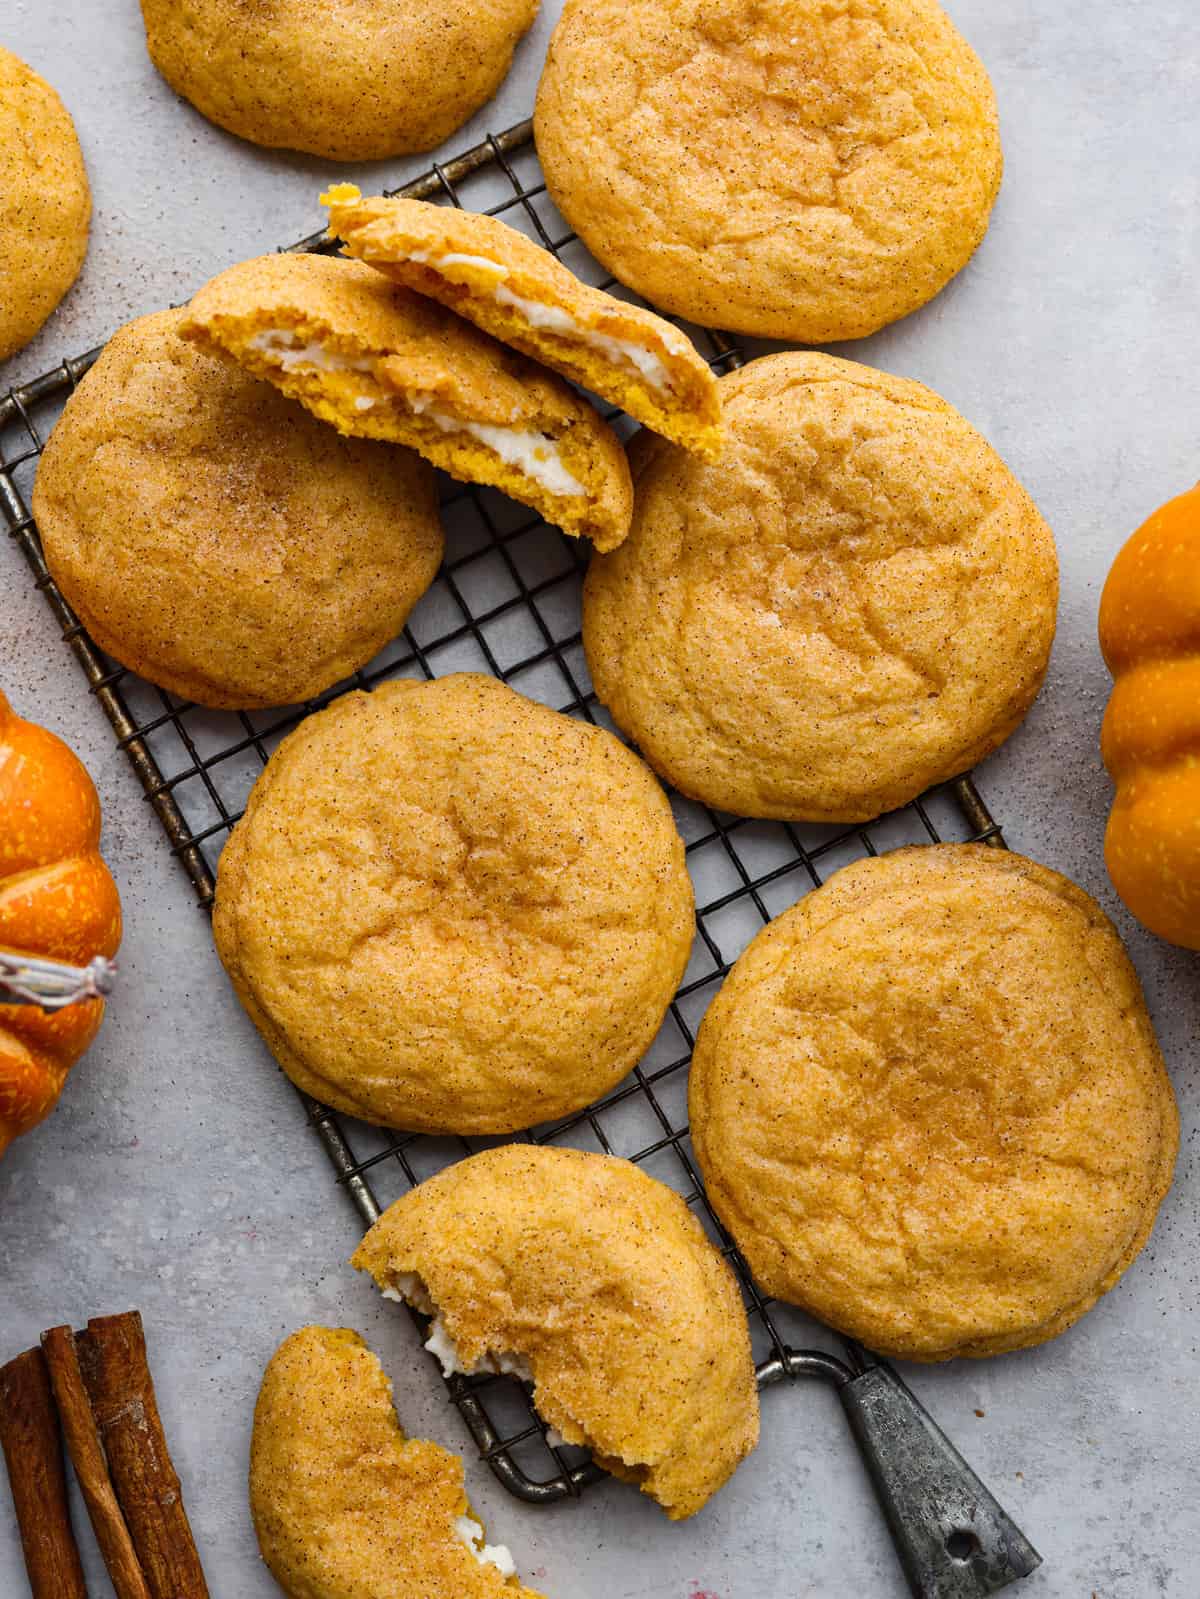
[0,694,122,1154]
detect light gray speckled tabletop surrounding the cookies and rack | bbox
[0,0,1200,1599]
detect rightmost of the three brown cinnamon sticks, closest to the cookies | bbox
[75,1310,208,1599]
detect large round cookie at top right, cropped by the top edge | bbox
[534,0,1002,344]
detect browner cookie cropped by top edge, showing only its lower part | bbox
[142,0,538,161]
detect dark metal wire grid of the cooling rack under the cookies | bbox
[0,122,1002,1501]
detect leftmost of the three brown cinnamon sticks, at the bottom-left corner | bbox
[0,1350,88,1599]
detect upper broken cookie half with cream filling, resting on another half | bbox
[322,184,722,457]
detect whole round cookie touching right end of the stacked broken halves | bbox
[584,353,1058,822]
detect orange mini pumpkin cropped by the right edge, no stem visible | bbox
[1099,484,1200,950]
